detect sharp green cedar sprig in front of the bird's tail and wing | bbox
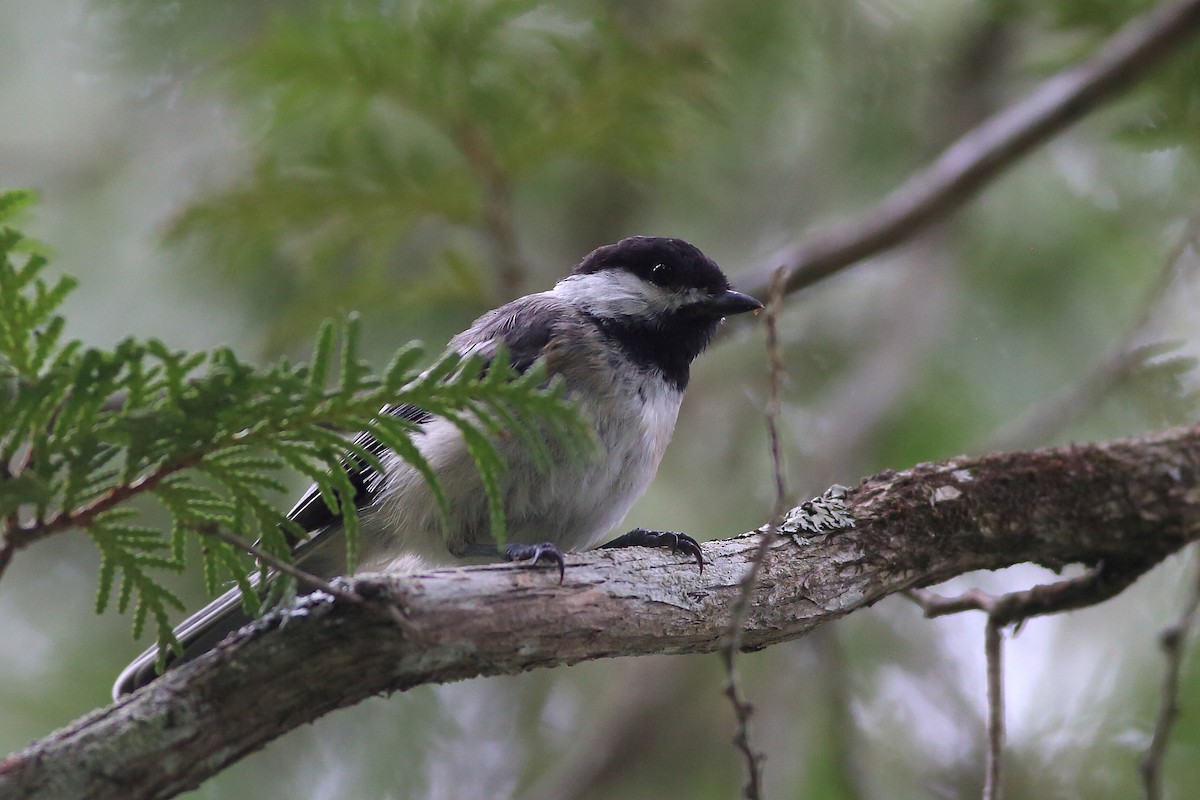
[0,191,590,662]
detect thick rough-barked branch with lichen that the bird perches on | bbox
[0,427,1200,800]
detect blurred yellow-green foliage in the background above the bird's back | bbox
[172,0,713,336]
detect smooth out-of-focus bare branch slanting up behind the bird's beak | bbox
[734,0,1200,294]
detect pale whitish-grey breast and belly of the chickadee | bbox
[350,293,683,569]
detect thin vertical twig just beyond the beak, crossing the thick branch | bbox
[721,270,787,800]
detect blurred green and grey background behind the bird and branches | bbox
[0,0,1200,800]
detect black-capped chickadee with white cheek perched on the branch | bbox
[113,236,763,699]
